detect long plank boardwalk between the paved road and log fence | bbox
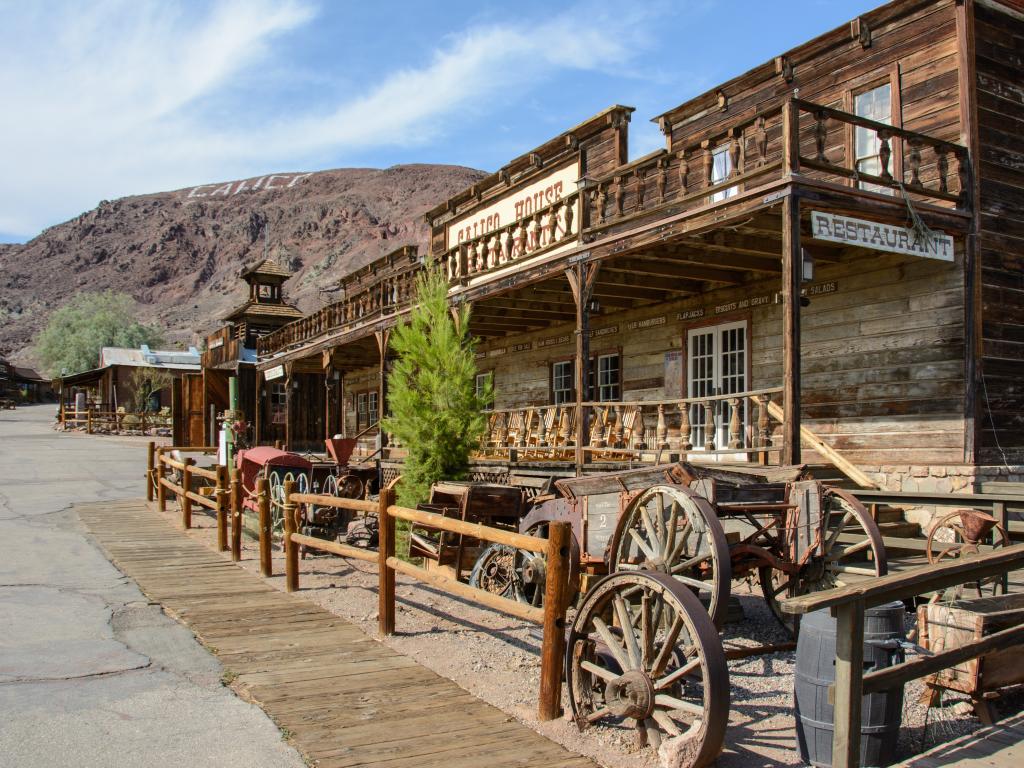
[76,501,596,768]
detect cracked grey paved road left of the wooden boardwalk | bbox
[0,406,303,768]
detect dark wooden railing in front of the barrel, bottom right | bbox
[781,544,1024,768]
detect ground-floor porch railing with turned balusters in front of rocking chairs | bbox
[477,387,782,462]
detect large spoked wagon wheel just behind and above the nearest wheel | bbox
[608,485,732,629]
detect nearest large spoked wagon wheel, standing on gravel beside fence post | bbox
[565,570,729,768]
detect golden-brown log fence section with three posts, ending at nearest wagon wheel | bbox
[284,481,570,720]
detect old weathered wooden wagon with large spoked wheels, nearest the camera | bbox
[464,463,886,765]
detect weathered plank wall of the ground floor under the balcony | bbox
[477,243,964,466]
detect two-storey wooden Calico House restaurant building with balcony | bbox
[258,0,1024,490]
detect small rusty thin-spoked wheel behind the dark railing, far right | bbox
[926,510,1010,600]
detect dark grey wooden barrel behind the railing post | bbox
[794,602,905,768]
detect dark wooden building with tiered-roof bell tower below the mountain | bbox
[186,259,302,445]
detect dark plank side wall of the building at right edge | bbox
[974,3,1024,464]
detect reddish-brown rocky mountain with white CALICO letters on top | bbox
[0,165,484,364]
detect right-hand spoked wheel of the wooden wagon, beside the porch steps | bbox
[758,487,889,636]
